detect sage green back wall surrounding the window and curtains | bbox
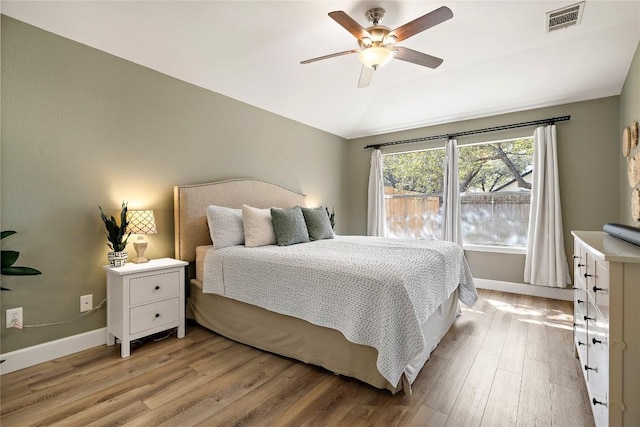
[348,96,620,283]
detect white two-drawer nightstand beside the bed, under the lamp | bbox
[104,258,188,357]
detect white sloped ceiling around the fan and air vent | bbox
[1,0,640,138]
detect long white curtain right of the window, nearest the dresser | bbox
[524,125,571,288]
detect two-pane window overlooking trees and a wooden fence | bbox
[383,137,533,247]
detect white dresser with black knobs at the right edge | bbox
[571,231,640,427]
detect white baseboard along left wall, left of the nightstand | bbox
[0,328,107,375]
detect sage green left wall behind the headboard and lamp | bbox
[0,16,347,353]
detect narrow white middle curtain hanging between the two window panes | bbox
[442,139,462,246]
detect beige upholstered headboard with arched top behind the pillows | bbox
[173,179,307,262]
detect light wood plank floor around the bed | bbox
[0,290,593,427]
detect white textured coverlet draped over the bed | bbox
[203,236,477,385]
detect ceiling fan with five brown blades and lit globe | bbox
[300,6,453,87]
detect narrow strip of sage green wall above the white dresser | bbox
[618,43,640,227]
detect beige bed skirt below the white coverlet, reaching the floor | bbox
[187,279,459,394]
